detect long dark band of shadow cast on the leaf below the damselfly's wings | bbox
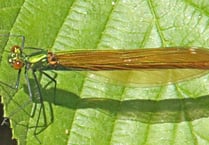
[39,83,209,124]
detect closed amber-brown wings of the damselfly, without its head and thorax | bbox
[52,48,209,71]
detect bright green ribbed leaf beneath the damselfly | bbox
[0,0,209,145]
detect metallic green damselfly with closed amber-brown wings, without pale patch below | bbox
[1,35,209,143]
